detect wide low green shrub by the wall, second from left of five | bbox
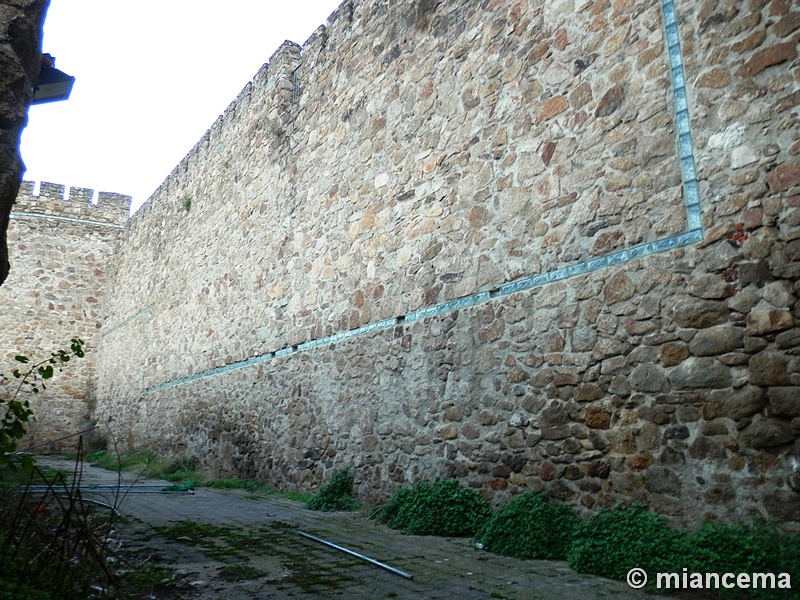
[375,479,491,537]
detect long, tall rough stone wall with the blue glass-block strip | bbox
[97,0,800,524]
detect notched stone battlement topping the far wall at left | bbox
[13,181,131,225]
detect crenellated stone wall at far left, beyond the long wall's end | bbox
[0,181,131,450]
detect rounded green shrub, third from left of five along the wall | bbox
[478,492,580,560]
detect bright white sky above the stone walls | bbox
[22,0,342,213]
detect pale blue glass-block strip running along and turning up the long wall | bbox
[141,0,703,394]
